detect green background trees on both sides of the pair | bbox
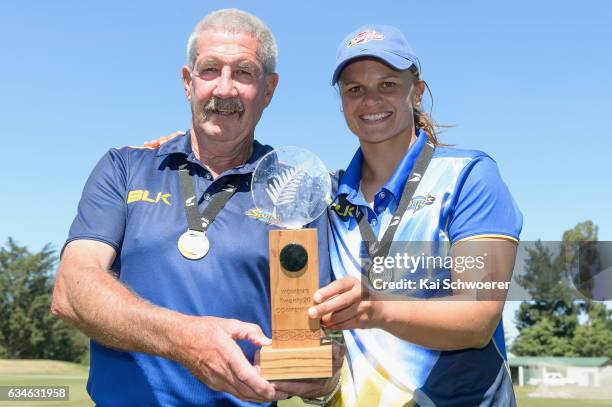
[0,221,612,363]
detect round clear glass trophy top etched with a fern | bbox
[251,146,331,229]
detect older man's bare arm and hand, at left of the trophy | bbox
[51,240,287,402]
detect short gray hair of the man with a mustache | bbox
[187,8,278,73]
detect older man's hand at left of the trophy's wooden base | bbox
[177,317,288,403]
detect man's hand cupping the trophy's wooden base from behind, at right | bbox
[255,341,346,400]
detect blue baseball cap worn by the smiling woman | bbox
[332,24,420,85]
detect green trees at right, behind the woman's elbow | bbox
[511,221,612,358]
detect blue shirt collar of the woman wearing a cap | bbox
[337,129,427,200]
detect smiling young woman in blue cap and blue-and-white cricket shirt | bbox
[309,25,522,406]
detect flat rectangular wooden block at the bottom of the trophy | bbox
[259,342,333,380]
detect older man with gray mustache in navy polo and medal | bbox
[52,10,335,406]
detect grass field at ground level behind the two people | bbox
[0,360,612,407]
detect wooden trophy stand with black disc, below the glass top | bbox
[259,229,333,380]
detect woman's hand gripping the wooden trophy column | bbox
[308,277,381,330]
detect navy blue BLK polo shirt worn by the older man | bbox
[67,132,330,406]
